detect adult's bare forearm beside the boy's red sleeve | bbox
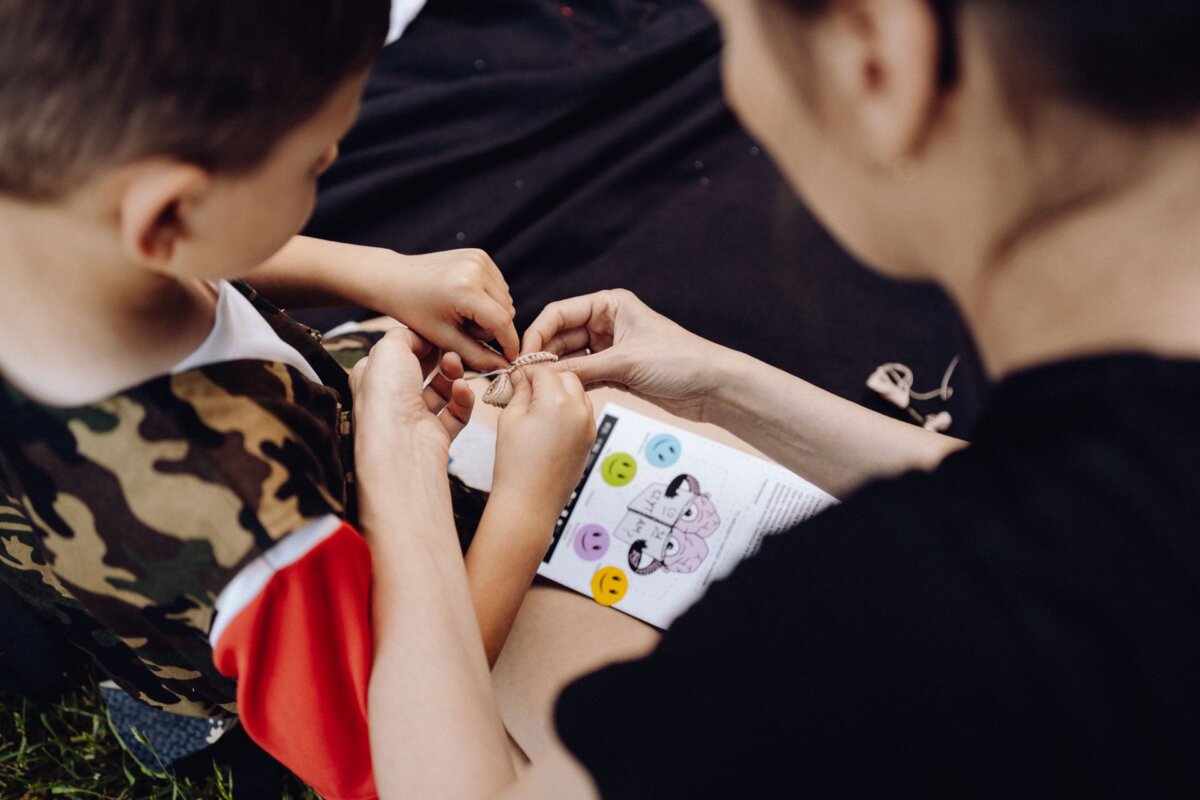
[360,456,514,798]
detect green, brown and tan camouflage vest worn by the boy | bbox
[0,284,374,717]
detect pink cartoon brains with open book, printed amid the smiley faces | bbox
[616,475,721,575]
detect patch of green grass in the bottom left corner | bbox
[0,688,318,800]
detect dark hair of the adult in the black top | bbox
[769,0,1200,125]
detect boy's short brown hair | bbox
[0,0,390,200]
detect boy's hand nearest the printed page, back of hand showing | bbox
[492,367,596,515]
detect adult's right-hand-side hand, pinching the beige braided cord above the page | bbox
[521,289,736,422]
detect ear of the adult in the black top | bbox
[817,0,941,167]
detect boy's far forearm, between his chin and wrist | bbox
[246,236,396,308]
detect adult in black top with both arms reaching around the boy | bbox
[355,0,1200,798]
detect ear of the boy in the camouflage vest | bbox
[119,161,211,272]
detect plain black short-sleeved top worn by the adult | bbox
[557,356,1200,799]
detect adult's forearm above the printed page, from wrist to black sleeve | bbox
[706,351,966,497]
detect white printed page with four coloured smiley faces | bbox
[538,403,836,628]
